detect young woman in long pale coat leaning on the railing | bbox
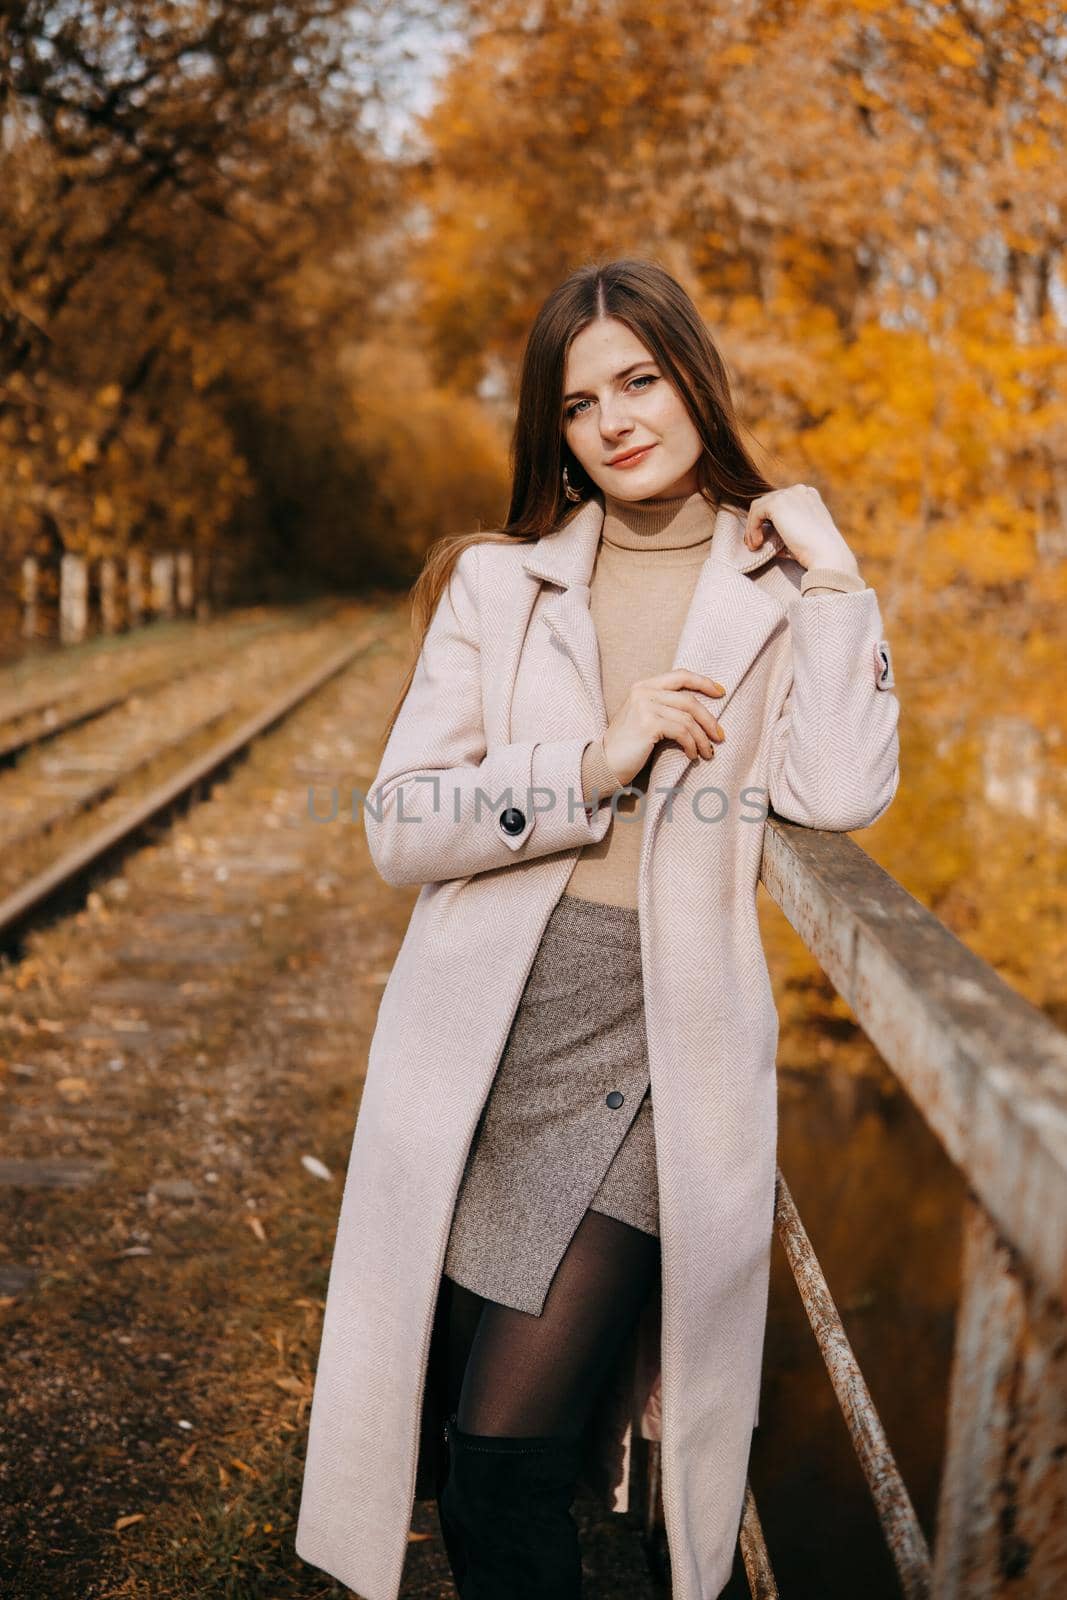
[296,259,899,1600]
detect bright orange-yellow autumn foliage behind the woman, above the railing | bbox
[403,0,1067,1005]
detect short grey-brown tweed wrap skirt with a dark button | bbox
[443,894,659,1315]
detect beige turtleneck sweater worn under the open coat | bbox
[563,491,867,907]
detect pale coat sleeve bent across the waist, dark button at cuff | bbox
[363,544,611,885]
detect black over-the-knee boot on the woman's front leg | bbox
[440,1418,582,1600]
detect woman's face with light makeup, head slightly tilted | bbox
[563,317,704,501]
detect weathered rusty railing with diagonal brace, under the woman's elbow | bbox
[633,816,1067,1600]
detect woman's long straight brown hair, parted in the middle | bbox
[382,258,774,746]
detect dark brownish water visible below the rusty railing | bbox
[742,1062,965,1600]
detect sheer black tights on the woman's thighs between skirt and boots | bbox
[440,1211,659,1437]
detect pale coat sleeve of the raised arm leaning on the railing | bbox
[768,587,901,832]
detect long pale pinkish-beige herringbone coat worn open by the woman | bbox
[296,499,899,1600]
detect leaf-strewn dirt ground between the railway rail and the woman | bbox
[0,608,654,1600]
